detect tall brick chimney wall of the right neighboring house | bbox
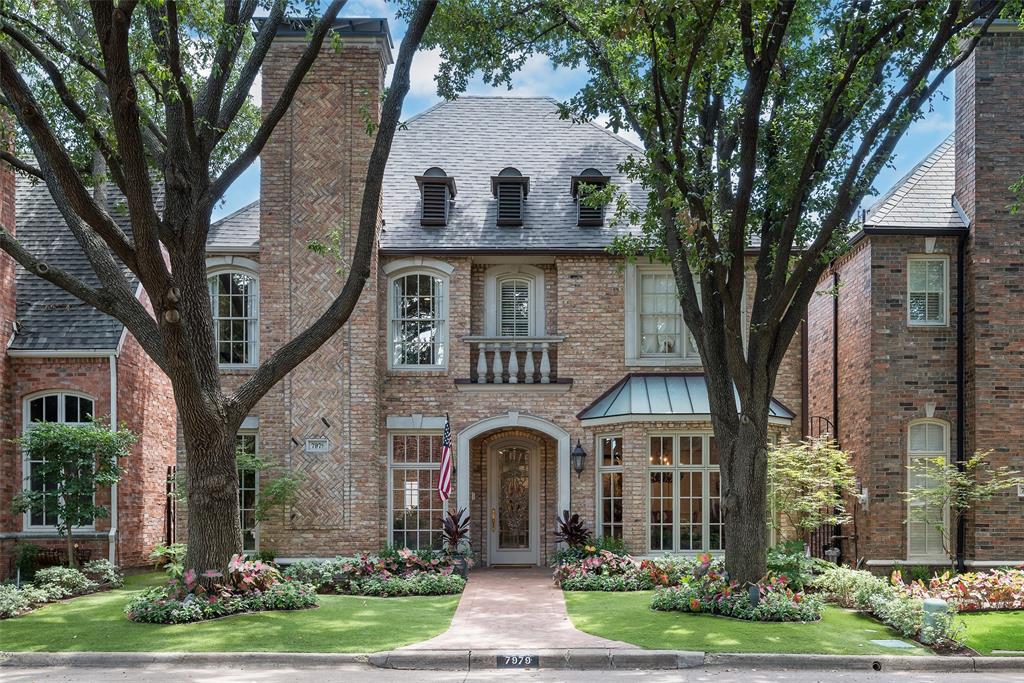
[955,31,1024,561]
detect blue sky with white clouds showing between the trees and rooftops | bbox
[213,0,953,219]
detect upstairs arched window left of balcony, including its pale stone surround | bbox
[385,259,452,370]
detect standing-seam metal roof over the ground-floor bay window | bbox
[577,373,796,420]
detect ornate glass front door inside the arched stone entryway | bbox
[487,441,541,564]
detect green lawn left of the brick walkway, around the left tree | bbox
[0,574,459,652]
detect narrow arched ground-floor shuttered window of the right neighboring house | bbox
[906,420,949,559]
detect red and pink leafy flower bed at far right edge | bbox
[891,569,1024,611]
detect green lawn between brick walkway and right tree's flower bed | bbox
[565,592,929,654]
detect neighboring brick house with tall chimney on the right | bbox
[808,25,1024,567]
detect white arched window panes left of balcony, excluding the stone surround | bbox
[391,272,446,368]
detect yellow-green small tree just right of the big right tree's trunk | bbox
[768,437,856,541]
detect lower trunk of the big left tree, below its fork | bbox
[181,419,242,574]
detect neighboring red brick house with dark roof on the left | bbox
[0,171,176,580]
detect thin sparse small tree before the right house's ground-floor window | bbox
[902,451,1024,570]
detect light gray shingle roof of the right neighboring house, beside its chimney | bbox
[864,135,967,230]
